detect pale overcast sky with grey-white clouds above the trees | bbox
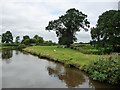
[0,0,119,42]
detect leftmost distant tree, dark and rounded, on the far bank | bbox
[2,31,13,43]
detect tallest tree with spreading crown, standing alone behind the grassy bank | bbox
[46,8,90,47]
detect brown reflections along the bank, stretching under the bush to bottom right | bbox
[47,63,118,90]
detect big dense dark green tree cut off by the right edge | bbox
[91,10,120,52]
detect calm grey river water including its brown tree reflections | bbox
[0,50,119,88]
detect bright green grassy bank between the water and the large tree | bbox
[23,46,103,69]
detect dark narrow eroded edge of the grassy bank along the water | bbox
[22,49,85,71]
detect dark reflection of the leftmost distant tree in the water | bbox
[2,49,13,63]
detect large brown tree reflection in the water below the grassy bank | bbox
[47,64,85,87]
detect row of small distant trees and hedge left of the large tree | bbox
[1,31,56,45]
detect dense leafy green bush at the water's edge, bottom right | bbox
[84,55,120,84]
